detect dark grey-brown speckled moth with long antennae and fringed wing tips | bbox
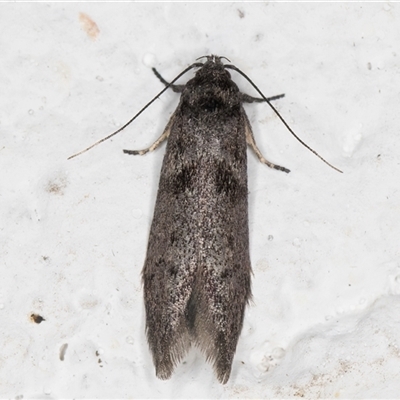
[70,55,341,383]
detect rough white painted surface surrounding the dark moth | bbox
[0,2,400,399]
